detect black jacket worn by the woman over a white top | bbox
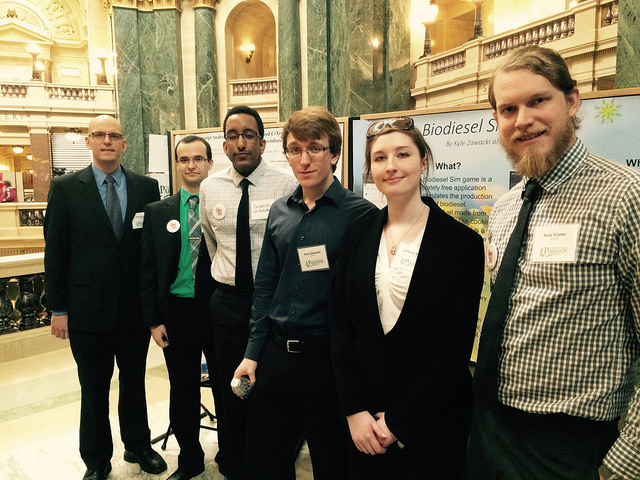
[329,198,484,448]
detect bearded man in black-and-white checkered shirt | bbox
[467,46,640,480]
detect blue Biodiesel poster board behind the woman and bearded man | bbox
[351,88,640,360]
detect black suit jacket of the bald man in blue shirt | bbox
[44,165,160,332]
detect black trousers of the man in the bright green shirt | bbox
[163,297,215,471]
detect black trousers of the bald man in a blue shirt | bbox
[69,313,151,469]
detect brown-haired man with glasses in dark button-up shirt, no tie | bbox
[234,107,377,480]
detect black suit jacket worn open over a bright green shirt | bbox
[141,192,215,327]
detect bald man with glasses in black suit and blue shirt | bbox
[44,115,167,480]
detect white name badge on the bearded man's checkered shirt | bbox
[531,223,580,263]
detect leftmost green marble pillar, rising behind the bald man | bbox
[113,7,184,173]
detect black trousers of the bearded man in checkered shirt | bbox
[466,405,618,480]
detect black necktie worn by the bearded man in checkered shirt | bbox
[473,179,540,412]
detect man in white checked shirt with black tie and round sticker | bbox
[200,106,296,480]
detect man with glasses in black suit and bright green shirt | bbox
[141,135,217,480]
